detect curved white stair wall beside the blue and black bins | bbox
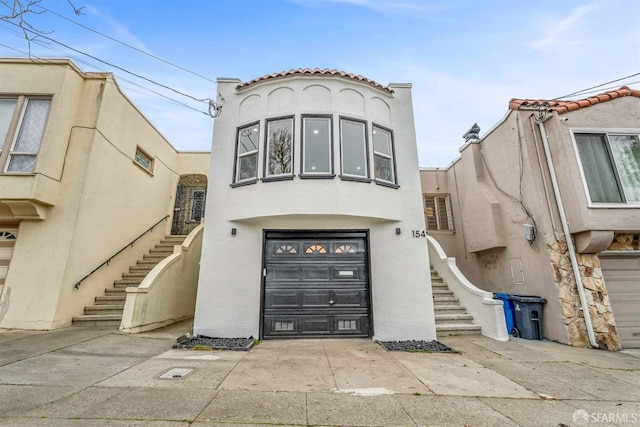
[427,236,509,341]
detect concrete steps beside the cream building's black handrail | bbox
[73,236,187,327]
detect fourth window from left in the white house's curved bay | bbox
[340,118,369,179]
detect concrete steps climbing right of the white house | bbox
[431,267,482,337]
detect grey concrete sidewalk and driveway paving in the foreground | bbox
[0,322,640,427]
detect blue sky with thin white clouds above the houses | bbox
[0,0,640,167]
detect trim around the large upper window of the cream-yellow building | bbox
[0,94,53,175]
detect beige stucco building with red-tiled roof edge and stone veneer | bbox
[421,87,640,350]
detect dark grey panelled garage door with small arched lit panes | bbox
[262,231,371,339]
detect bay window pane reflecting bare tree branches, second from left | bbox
[264,117,293,178]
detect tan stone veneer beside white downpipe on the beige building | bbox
[545,234,621,351]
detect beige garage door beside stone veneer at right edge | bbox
[600,254,640,348]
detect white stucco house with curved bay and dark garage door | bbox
[194,69,435,340]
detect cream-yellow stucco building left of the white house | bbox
[0,58,210,329]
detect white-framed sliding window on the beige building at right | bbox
[574,132,640,203]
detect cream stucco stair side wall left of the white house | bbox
[120,224,204,333]
